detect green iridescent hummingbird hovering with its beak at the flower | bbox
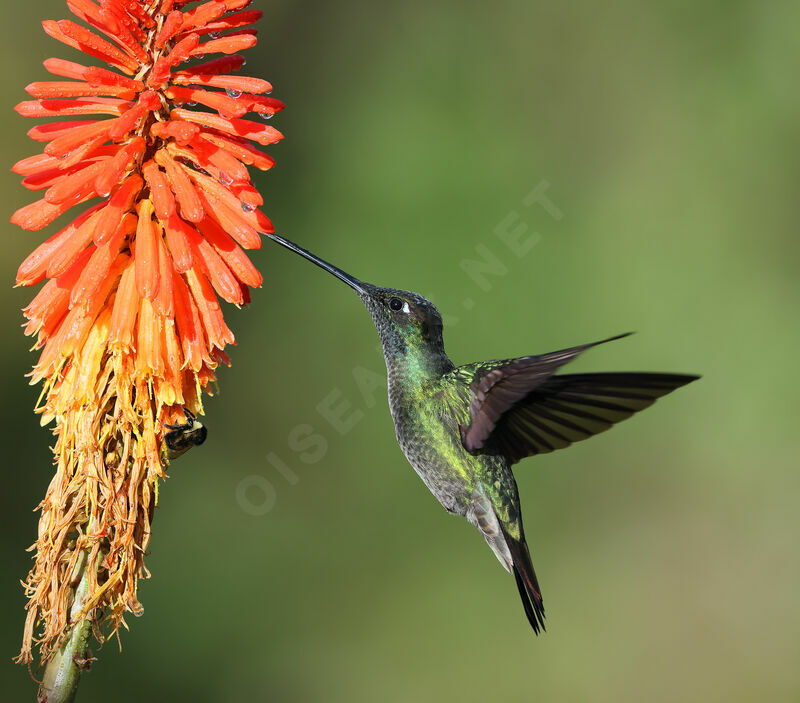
[267,233,699,635]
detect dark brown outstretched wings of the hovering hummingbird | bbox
[461,340,698,463]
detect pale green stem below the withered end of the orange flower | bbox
[36,552,92,703]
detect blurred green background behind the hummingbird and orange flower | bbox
[0,0,800,703]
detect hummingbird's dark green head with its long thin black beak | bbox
[267,233,444,355]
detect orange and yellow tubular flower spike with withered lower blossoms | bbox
[11,0,283,662]
